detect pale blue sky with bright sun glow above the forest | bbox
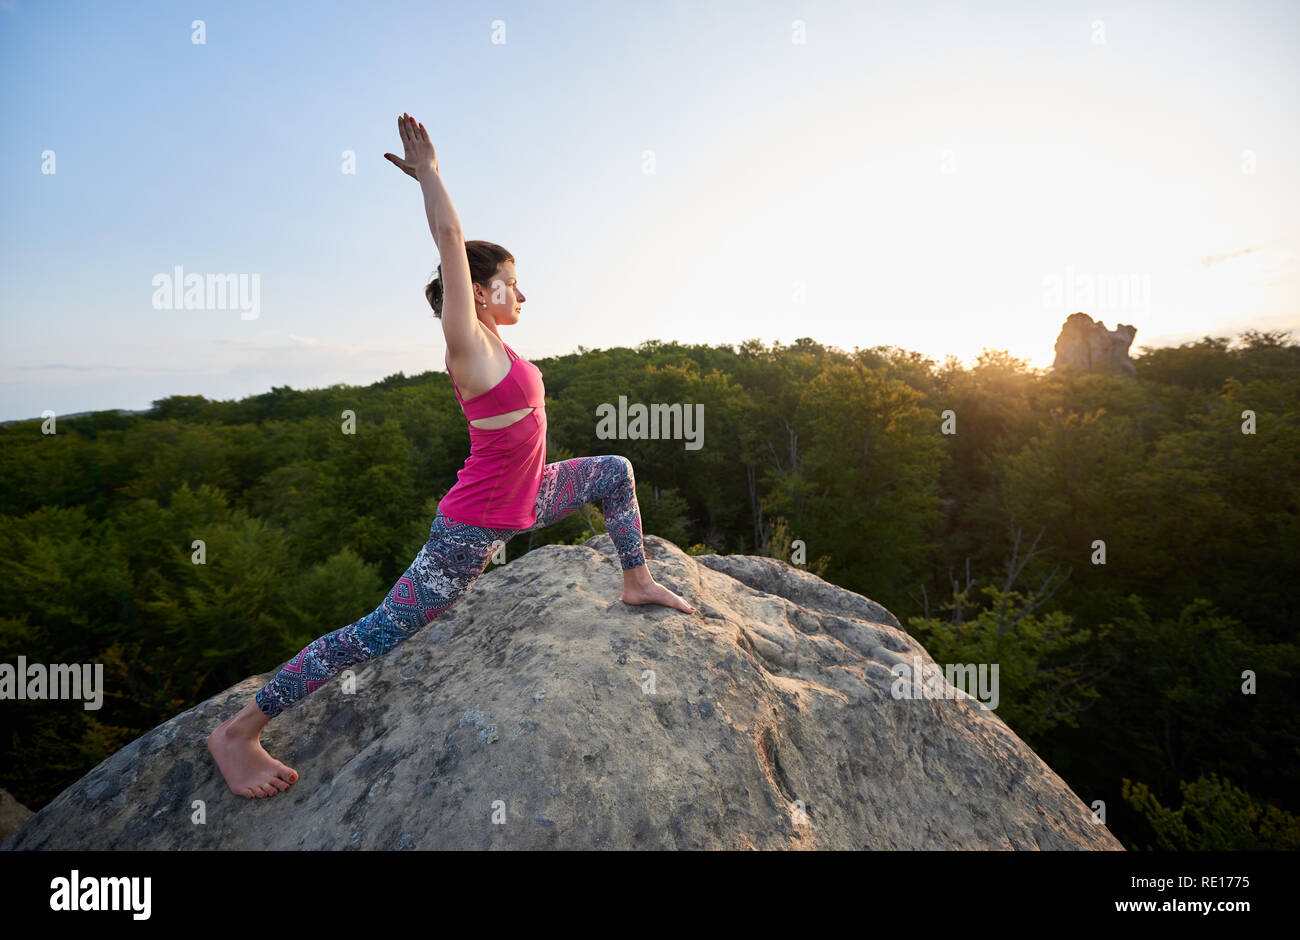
[0,0,1300,420]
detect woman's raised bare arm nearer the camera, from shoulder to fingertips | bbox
[394,114,485,363]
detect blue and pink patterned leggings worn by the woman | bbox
[256,455,646,718]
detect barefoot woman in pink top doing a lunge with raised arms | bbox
[208,114,696,797]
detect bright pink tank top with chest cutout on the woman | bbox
[438,339,546,529]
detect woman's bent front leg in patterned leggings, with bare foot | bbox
[523,454,696,614]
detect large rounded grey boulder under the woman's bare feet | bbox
[4,534,1122,850]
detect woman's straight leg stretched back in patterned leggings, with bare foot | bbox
[208,515,510,797]
